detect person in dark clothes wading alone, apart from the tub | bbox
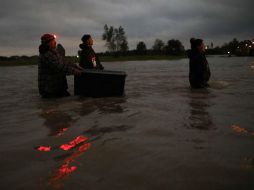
[187,38,211,88]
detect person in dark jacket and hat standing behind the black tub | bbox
[78,34,104,70]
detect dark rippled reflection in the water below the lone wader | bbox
[187,89,214,130]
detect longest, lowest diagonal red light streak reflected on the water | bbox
[49,143,91,183]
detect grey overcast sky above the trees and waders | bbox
[0,0,254,56]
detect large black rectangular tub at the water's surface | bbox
[74,69,127,97]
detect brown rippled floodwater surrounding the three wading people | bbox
[0,56,254,190]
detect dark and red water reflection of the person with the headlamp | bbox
[36,101,91,188]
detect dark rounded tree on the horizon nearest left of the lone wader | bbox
[165,39,184,55]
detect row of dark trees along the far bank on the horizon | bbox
[102,25,254,56]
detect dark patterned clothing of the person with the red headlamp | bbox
[38,50,75,98]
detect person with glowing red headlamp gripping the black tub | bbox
[38,34,82,98]
